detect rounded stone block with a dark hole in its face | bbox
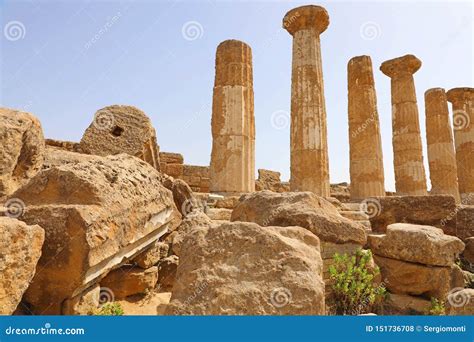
[80,105,160,170]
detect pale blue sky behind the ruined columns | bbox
[0,0,474,190]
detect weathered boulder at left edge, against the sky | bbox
[0,108,45,200]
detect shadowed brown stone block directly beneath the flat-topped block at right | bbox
[374,255,464,300]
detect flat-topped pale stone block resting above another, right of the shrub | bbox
[367,223,464,267]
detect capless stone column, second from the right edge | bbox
[425,88,460,203]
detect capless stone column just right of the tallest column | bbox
[347,56,385,200]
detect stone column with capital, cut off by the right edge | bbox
[447,88,474,204]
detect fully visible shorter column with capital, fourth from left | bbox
[380,55,427,195]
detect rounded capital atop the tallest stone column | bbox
[283,5,329,35]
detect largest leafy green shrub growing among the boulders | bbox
[329,250,386,315]
